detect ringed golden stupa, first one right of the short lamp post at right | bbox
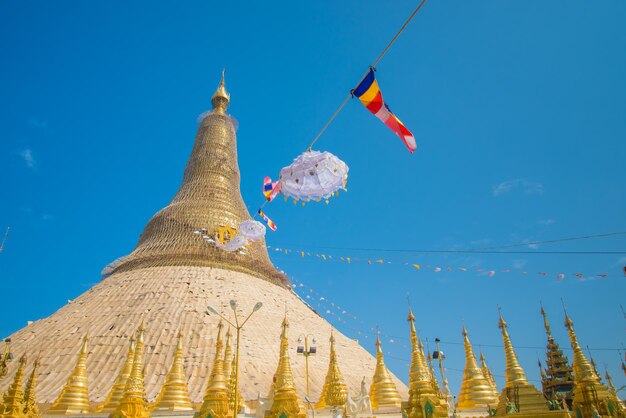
[456,327,498,417]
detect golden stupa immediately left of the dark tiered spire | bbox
[495,314,569,418]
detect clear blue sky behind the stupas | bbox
[0,0,626,393]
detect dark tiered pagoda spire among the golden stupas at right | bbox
[540,306,574,409]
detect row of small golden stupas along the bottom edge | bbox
[0,311,626,418]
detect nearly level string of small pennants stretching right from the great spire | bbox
[267,245,609,281]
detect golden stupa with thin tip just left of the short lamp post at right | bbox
[407,310,448,418]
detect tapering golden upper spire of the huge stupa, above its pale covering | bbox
[112,73,287,286]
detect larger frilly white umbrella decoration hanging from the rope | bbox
[280,151,348,202]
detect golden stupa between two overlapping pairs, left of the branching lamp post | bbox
[152,331,193,411]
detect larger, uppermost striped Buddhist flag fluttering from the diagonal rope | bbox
[352,69,417,153]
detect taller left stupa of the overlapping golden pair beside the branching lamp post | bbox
[194,321,229,418]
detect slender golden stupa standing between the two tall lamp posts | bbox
[265,315,306,418]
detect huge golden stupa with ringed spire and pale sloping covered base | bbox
[0,77,407,408]
